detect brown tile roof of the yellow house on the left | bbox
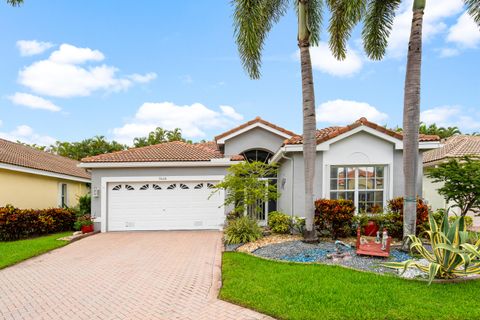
[0,139,90,179]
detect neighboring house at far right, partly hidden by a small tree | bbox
[423,135,480,228]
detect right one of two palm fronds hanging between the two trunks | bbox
[362,0,401,60]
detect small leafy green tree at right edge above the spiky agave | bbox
[426,157,480,216]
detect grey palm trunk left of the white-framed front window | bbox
[298,0,318,242]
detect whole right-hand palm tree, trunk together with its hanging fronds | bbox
[331,0,480,246]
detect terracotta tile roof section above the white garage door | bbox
[82,141,243,163]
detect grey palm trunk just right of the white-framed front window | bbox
[403,0,425,250]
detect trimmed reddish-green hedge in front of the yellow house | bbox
[0,205,76,241]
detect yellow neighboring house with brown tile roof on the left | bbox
[0,139,90,209]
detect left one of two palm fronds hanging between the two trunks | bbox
[327,0,367,60]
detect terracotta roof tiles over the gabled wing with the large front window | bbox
[284,118,440,144]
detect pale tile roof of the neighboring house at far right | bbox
[423,135,480,163]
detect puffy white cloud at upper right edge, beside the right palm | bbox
[447,12,480,48]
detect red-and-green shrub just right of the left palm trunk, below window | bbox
[315,199,355,239]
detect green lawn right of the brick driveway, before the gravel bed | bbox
[220,252,480,320]
